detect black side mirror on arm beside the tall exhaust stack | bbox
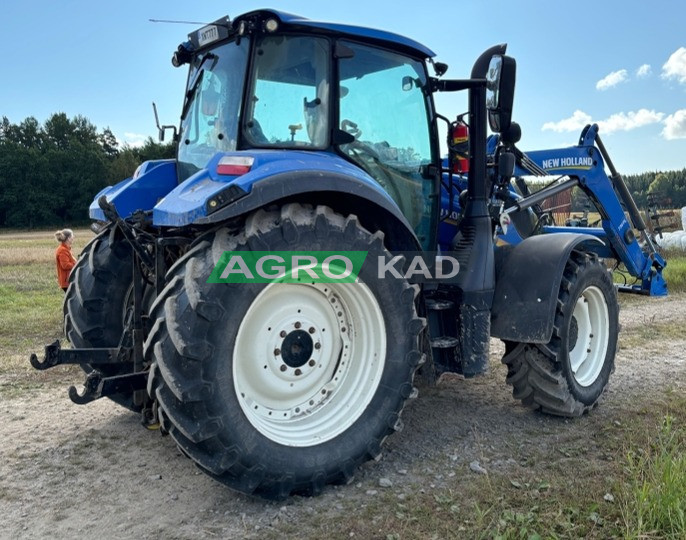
[486,54,517,133]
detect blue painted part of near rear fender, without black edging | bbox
[152,150,397,227]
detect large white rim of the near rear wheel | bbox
[233,282,386,447]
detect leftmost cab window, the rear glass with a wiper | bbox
[178,38,249,181]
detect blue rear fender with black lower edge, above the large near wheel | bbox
[153,150,421,250]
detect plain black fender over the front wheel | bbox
[491,233,602,343]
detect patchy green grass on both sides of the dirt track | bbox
[0,230,686,540]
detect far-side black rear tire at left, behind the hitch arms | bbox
[63,228,140,411]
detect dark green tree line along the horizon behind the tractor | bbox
[0,113,686,228]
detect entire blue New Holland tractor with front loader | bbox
[31,10,666,498]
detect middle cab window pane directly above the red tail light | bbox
[243,36,330,149]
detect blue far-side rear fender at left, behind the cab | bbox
[88,159,177,221]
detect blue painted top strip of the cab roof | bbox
[236,9,436,58]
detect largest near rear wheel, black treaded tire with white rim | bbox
[145,204,425,499]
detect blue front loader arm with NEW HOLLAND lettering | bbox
[505,124,667,296]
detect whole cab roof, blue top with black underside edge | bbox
[234,9,436,58]
